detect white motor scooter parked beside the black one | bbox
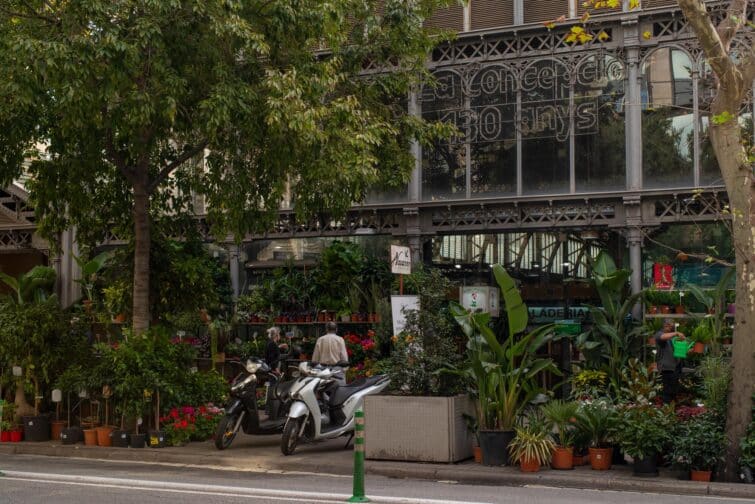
[281,362,390,455]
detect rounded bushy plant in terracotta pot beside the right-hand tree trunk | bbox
[672,411,726,481]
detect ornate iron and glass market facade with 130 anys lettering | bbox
[0,0,752,307]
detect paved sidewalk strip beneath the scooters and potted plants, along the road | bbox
[0,435,755,500]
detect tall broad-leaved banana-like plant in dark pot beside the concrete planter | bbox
[452,264,560,465]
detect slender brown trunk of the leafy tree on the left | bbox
[133,179,151,335]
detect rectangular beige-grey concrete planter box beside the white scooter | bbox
[364,395,474,462]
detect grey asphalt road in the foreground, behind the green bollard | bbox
[0,455,752,504]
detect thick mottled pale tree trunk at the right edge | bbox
[711,92,755,481]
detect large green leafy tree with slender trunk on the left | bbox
[0,0,451,334]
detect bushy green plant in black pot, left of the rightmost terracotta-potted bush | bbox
[613,404,674,476]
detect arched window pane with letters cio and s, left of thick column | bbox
[574,56,626,192]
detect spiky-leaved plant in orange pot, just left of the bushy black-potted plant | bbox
[577,399,616,471]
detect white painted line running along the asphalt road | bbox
[2,471,491,504]
